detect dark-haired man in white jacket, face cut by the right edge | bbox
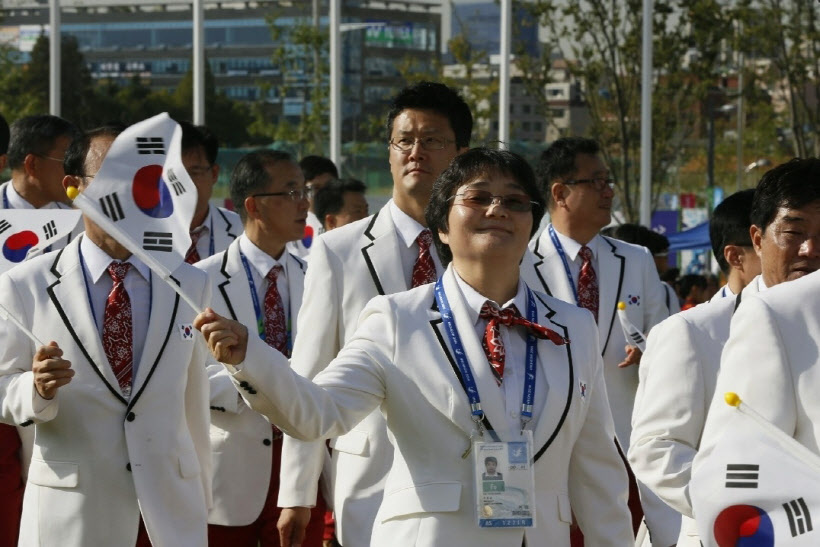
[629,158,820,547]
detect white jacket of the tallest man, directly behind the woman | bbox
[279,203,442,546]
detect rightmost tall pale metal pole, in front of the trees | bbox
[640,0,653,227]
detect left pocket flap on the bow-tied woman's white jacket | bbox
[378,481,461,522]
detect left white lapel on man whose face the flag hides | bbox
[46,238,128,405]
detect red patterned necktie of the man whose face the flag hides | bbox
[102,262,134,398]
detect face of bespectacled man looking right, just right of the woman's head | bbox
[559,154,615,231]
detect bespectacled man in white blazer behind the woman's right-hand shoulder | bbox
[522,137,680,547]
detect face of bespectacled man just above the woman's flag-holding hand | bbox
[250,161,308,242]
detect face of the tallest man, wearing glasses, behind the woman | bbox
[387,108,467,206]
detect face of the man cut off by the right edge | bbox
[750,200,820,287]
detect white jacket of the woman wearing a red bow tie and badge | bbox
[226,268,634,547]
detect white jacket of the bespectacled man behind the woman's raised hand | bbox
[196,239,305,526]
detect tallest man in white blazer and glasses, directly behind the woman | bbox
[279,82,472,547]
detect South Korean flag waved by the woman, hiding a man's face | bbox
[74,113,197,278]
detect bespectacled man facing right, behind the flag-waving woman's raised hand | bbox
[197,151,324,547]
